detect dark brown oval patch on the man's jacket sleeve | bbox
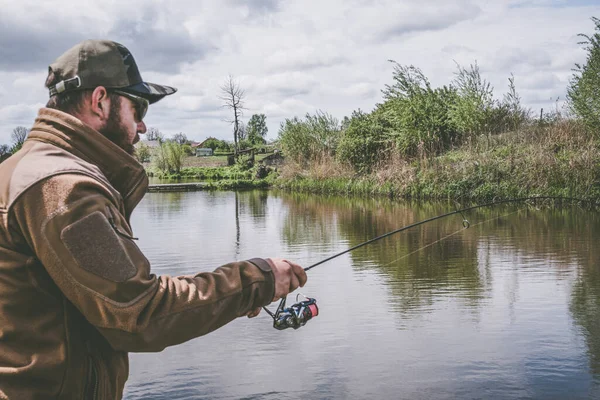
[60,211,137,282]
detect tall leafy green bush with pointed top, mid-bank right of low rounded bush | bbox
[376,61,457,155]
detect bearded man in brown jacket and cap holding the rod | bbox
[0,40,306,400]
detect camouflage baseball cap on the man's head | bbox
[48,40,177,104]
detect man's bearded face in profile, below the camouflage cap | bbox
[99,95,146,155]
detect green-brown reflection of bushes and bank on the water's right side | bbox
[283,194,600,379]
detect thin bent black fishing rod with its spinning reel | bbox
[263,196,598,330]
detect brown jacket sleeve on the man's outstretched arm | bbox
[13,174,275,351]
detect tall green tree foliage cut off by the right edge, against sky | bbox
[567,17,600,134]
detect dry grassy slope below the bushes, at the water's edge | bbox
[275,120,600,201]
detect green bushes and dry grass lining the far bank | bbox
[139,18,600,201]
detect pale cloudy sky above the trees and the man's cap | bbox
[0,0,600,144]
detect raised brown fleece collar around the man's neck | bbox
[27,108,148,214]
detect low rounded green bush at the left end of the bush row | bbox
[279,111,341,164]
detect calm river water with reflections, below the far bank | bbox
[125,191,600,400]
